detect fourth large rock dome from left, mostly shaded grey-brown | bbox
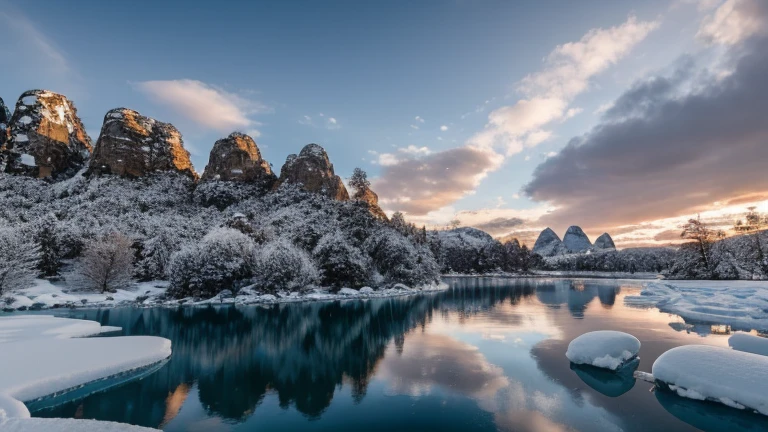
[275,144,349,201]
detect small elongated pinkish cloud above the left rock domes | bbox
[133,79,269,132]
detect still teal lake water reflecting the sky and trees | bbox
[31,278,768,432]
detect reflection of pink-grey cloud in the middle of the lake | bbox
[379,333,509,399]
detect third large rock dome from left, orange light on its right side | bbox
[201,132,277,187]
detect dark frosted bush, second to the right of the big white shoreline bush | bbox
[312,231,371,288]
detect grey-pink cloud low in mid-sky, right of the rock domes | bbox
[373,147,500,215]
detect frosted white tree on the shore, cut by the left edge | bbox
[0,228,40,294]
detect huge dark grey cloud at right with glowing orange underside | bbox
[524,34,768,233]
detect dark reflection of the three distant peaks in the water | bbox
[536,280,621,318]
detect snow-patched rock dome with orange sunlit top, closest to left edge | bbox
[0,90,92,179]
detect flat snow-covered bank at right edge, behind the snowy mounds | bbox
[624,281,768,330]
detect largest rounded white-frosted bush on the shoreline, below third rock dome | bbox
[168,228,254,297]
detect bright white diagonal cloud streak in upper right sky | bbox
[470,16,658,156]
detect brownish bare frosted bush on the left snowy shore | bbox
[67,232,133,292]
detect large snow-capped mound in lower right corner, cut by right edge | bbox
[652,345,768,415]
